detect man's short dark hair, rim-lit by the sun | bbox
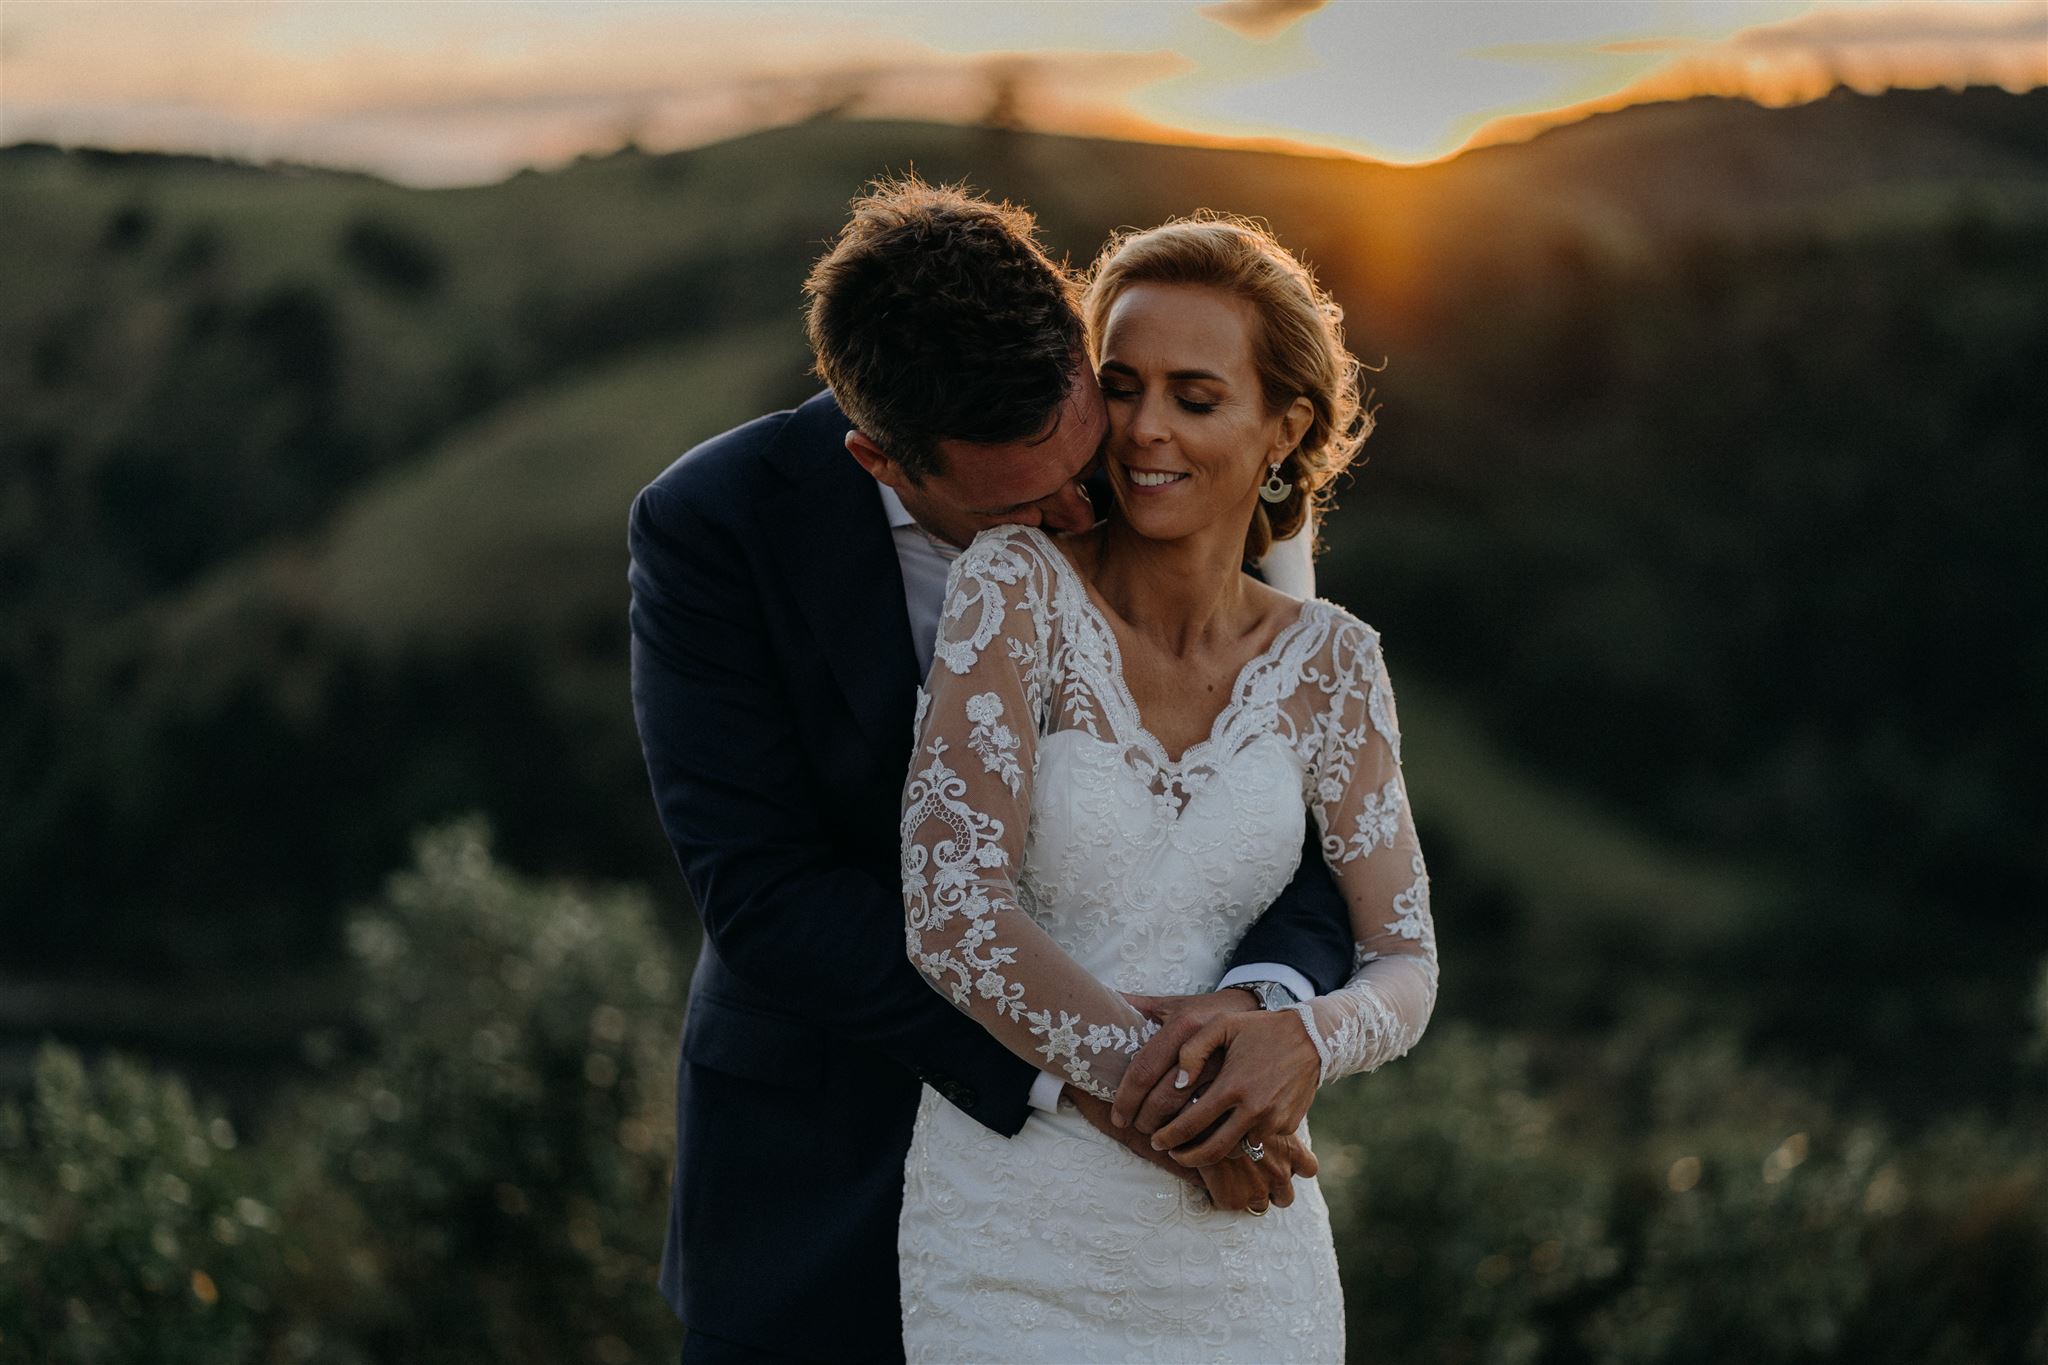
[803,176,1085,483]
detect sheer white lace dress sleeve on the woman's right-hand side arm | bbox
[1294,620,1438,1081]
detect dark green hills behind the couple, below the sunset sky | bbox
[0,90,2048,1031]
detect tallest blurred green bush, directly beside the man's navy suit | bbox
[285,821,682,1365]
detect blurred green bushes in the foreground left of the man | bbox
[0,821,682,1365]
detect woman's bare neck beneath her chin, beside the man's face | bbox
[1090,518,1249,655]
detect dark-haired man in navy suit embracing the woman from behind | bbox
[629,180,1352,1361]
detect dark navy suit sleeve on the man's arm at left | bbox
[629,474,1034,1134]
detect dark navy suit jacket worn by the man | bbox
[629,393,1352,1361]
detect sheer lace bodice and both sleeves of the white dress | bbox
[901,526,1438,1099]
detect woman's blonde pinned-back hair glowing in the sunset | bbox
[1081,211,1372,559]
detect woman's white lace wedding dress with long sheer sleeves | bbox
[897,517,1438,1361]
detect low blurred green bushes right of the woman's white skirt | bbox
[1313,1017,2048,1365]
